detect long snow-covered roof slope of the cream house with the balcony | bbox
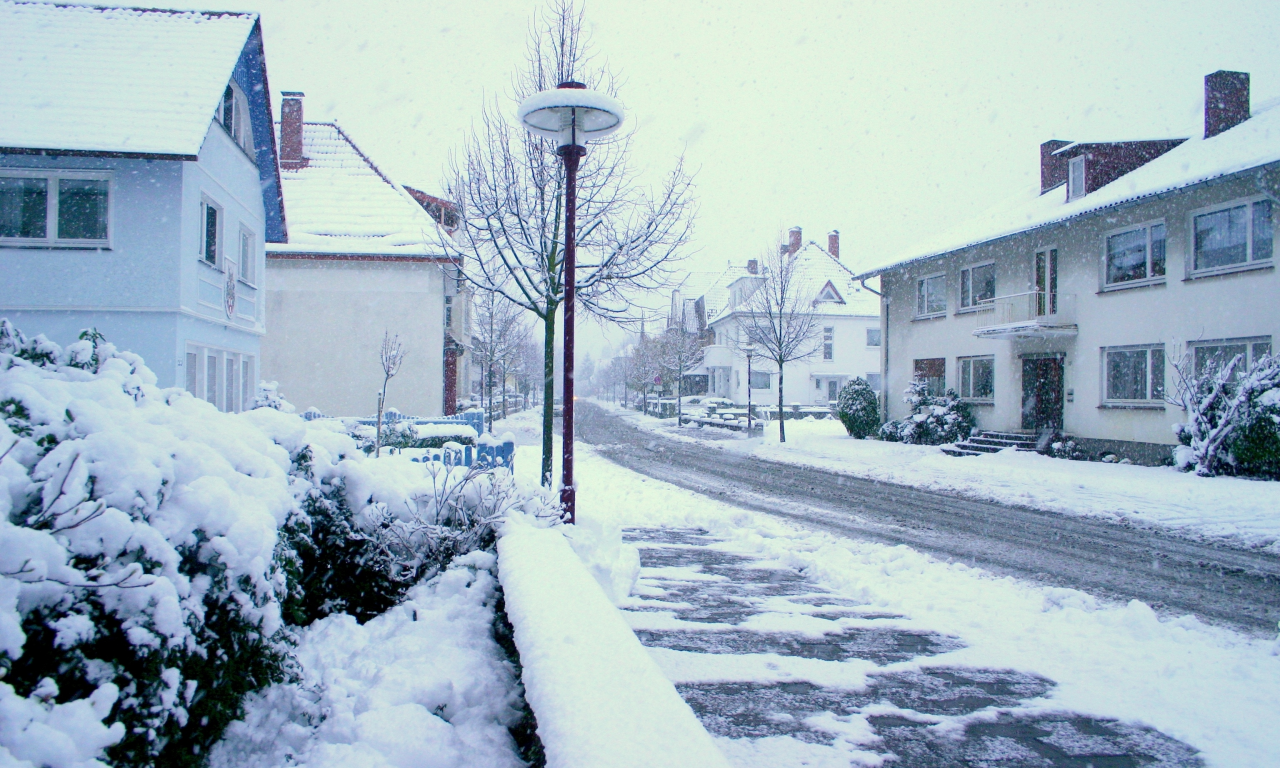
[859,105,1280,276]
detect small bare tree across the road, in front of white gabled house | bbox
[739,251,819,443]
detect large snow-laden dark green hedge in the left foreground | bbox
[0,321,552,767]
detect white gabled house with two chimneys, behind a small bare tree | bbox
[695,227,881,406]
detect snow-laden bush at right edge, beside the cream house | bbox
[1170,355,1280,479]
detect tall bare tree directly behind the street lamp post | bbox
[445,0,694,485]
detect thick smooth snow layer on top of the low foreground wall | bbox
[498,517,728,768]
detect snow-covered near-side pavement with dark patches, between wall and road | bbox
[486,417,1280,767]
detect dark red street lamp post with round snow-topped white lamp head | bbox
[517,81,622,522]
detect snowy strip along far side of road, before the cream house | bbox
[599,403,1280,553]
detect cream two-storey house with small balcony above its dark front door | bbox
[859,72,1280,462]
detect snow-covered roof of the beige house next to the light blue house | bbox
[266,123,447,259]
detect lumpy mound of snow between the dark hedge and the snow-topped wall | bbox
[210,552,522,768]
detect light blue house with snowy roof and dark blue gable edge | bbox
[0,0,285,411]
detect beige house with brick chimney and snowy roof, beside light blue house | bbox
[262,92,467,416]
